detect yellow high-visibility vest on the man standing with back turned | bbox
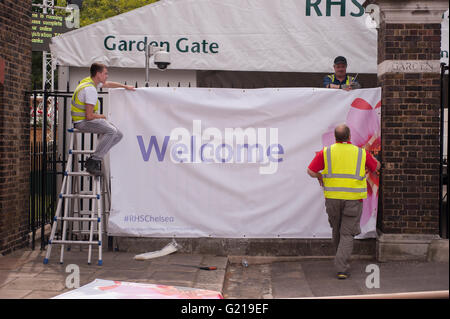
[322,143,367,200]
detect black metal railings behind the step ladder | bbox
[27,86,108,249]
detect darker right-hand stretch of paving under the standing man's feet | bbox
[224,259,449,298]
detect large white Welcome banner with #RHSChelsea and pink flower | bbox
[108,88,381,238]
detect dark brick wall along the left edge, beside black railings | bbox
[0,0,31,254]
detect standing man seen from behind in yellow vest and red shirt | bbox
[307,124,380,279]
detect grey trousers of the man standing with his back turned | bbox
[325,198,363,272]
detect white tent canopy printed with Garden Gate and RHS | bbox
[50,0,377,73]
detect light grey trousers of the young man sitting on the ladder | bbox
[74,119,123,160]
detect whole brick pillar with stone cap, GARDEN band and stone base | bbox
[372,0,448,261]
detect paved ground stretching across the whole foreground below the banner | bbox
[0,249,449,299]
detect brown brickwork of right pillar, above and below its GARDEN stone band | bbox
[378,23,441,234]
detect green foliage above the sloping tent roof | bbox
[80,0,158,27]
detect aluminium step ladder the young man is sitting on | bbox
[44,128,109,266]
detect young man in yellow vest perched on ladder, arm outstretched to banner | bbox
[71,63,134,176]
